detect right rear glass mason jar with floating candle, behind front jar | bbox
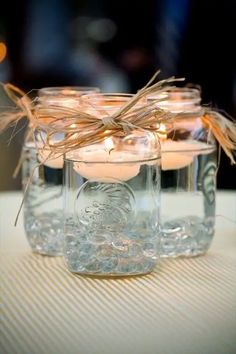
[149,88,217,257]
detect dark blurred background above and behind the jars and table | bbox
[0,0,236,190]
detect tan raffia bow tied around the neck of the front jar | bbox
[35,73,183,154]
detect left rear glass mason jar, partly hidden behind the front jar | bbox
[22,87,99,256]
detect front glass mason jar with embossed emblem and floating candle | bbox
[64,94,160,276]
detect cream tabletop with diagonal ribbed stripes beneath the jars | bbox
[0,192,236,354]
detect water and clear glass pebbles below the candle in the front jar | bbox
[64,161,160,276]
